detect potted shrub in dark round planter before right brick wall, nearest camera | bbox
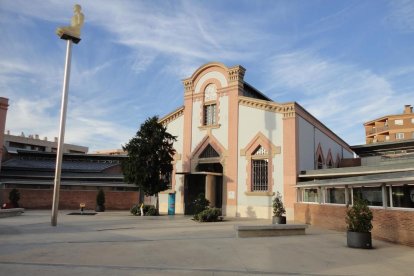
[345,197,373,249]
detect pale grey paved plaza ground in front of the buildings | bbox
[0,211,414,276]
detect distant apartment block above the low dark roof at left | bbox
[4,131,88,154]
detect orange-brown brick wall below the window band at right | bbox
[295,203,414,246]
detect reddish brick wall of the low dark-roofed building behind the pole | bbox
[1,189,139,210]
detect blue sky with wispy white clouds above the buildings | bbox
[0,0,414,152]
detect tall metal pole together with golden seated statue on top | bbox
[51,5,85,226]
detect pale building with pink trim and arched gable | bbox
[160,62,353,220]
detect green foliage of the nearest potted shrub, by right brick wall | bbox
[345,197,373,233]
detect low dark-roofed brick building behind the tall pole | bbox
[0,150,140,210]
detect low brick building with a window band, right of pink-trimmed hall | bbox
[295,139,414,246]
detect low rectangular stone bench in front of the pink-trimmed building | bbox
[235,224,308,238]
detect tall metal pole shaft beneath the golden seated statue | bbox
[52,39,72,226]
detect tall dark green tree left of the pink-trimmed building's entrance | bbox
[122,116,177,209]
